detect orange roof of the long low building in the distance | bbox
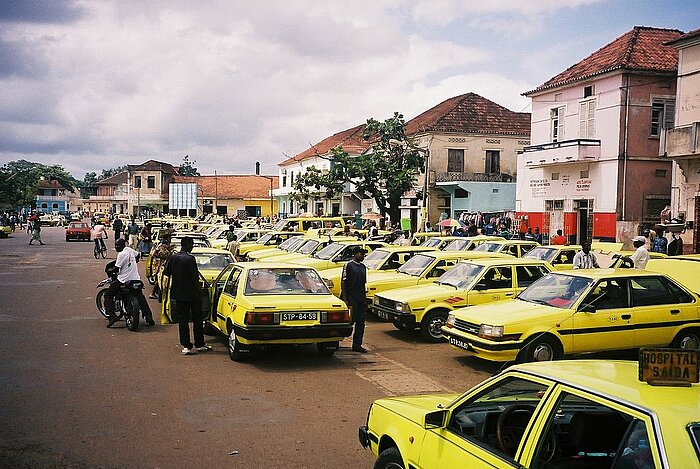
[172,174,279,199]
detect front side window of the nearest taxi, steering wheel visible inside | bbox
[447,378,548,458]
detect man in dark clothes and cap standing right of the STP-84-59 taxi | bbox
[340,246,367,353]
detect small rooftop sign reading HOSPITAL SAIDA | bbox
[639,348,700,386]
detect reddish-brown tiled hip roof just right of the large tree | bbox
[406,93,530,136]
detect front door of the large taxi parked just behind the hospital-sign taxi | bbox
[572,278,634,353]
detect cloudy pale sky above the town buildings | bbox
[0,0,700,179]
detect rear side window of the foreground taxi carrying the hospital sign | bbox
[532,393,636,469]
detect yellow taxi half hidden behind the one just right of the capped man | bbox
[367,251,510,304]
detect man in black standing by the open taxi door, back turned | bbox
[163,236,211,355]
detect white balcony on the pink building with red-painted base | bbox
[523,138,600,166]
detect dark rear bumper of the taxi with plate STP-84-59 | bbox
[233,324,352,343]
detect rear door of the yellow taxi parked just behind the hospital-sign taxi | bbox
[630,276,698,347]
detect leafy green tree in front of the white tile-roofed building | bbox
[292,112,425,222]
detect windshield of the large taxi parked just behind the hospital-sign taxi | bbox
[518,273,593,309]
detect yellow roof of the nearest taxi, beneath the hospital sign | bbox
[508,359,700,423]
